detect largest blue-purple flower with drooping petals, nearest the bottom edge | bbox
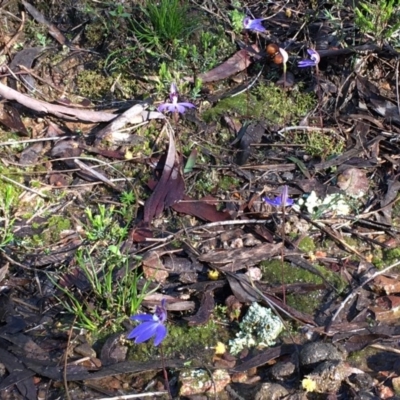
[127,299,168,346]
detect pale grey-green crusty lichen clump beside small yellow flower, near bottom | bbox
[229,303,284,355]
